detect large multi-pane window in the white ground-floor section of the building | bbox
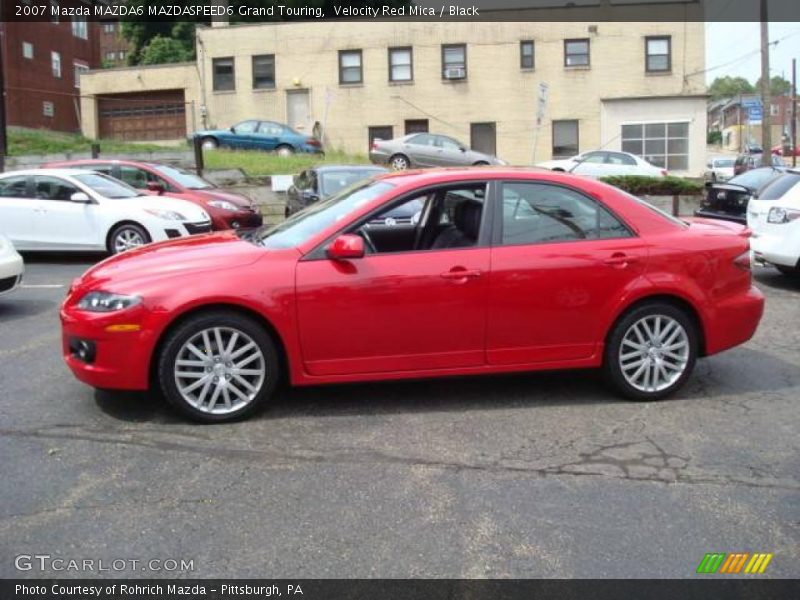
[622,122,689,171]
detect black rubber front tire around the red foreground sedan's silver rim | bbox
[157,310,280,423]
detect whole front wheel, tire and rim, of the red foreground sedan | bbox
[158,311,280,423]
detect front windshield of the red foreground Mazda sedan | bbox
[254,180,394,249]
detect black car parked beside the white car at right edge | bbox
[694,167,785,224]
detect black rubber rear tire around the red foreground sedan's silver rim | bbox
[603,301,699,401]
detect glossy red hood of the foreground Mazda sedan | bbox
[73,231,265,292]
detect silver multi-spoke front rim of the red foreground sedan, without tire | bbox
[173,327,267,415]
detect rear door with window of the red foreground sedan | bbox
[487,182,647,365]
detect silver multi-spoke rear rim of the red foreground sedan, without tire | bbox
[619,315,689,392]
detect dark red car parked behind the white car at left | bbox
[45,159,264,230]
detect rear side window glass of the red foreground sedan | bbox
[501,182,631,245]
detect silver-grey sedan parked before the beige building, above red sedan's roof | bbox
[369,133,506,171]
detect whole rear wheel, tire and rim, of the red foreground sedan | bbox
[604,302,698,400]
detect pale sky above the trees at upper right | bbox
[706,22,800,83]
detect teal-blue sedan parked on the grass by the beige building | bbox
[189,119,322,156]
